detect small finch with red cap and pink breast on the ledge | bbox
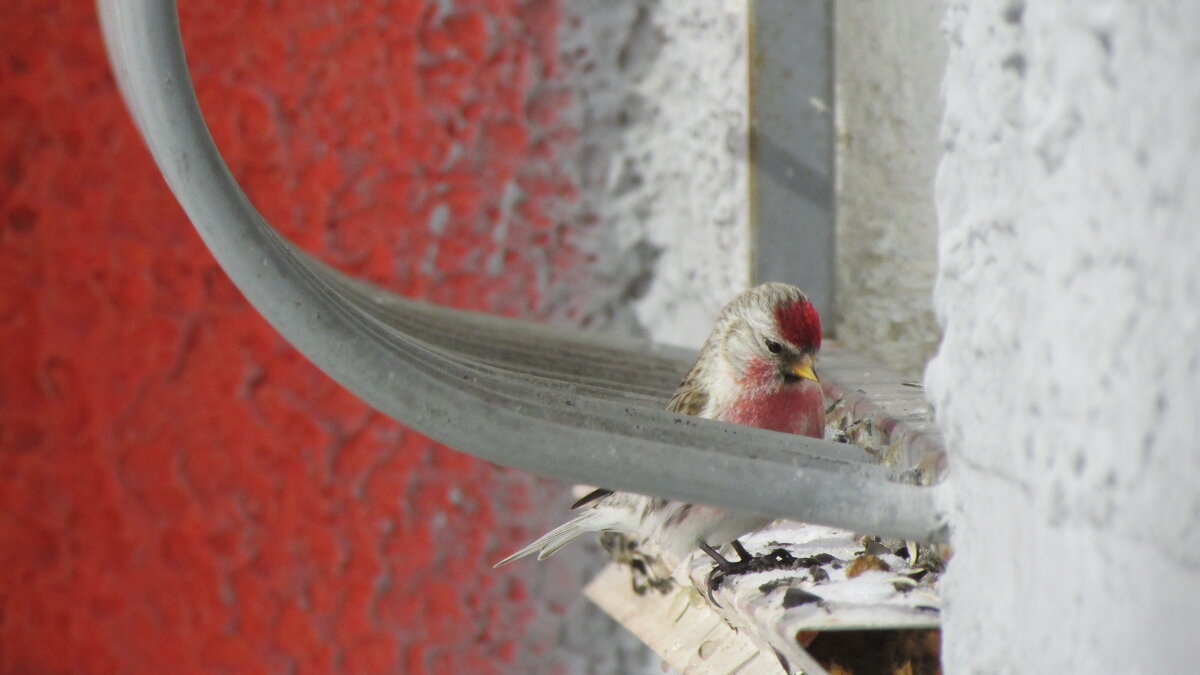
[496,283,824,567]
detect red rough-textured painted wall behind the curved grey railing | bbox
[0,0,583,674]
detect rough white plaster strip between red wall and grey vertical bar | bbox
[560,0,750,346]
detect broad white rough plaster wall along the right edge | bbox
[926,0,1200,673]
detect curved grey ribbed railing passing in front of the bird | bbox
[100,0,947,540]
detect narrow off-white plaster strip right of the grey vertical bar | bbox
[834,0,946,377]
